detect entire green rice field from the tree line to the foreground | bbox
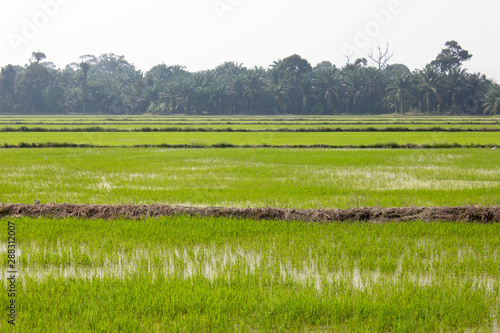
[0,116,500,332]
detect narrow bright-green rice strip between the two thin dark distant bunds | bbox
[0,132,500,146]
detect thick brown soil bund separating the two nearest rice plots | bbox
[0,203,500,223]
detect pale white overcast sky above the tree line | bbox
[0,0,500,81]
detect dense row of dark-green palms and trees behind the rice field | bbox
[0,41,500,115]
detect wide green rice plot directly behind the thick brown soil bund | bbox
[0,148,500,208]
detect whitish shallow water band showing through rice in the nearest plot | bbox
[0,243,500,291]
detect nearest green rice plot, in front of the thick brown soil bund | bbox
[0,217,500,332]
